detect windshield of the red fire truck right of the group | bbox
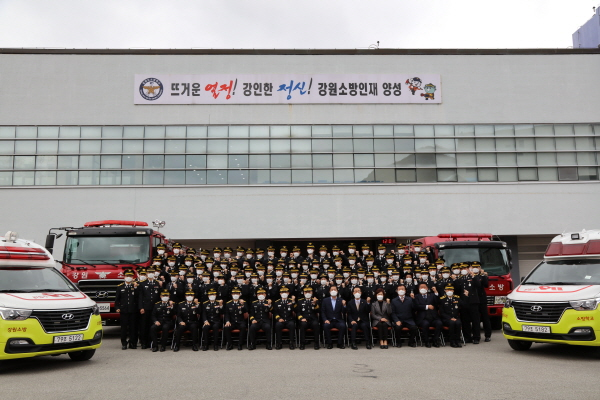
[443,247,510,276]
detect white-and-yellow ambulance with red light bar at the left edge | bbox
[0,231,102,361]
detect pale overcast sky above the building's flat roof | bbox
[0,0,600,49]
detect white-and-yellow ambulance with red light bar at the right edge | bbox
[502,230,600,351]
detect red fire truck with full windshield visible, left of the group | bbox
[46,220,169,325]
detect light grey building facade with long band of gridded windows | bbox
[0,49,600,273]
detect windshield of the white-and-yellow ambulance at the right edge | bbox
[522,260,600,285]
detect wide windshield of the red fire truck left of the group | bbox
[64,236,150,264]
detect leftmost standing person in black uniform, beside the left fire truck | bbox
[115,270,139,350]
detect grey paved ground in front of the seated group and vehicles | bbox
[0,328,600,400]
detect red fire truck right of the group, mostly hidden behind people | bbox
[414,233,514,329]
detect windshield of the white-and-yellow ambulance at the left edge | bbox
[0,266,78,293]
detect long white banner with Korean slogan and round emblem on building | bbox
[133,74,442,104]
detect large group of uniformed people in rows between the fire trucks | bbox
[115,242,491,351]
